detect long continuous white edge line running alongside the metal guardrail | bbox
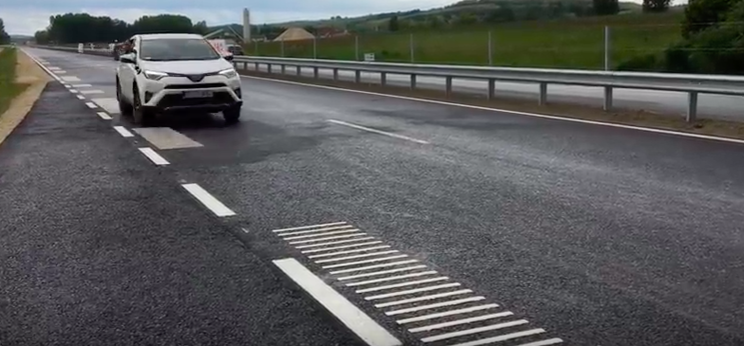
[241,75,744,144]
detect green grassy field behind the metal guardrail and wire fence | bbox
[245,11,684,69]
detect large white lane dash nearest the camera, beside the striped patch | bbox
[273,258,402,346]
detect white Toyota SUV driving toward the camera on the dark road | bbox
[116,34,243,126]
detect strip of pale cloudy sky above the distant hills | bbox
[0,0,457,35]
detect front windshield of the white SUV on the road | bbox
[139,38,220,61]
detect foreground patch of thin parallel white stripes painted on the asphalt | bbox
[272,222,563,346]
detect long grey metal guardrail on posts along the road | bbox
[40,46,744,122]
